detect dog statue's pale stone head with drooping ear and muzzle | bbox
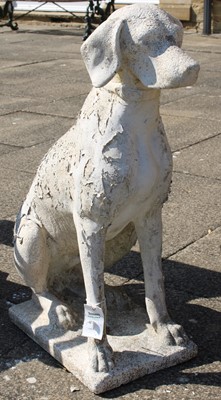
[81,4,199,89]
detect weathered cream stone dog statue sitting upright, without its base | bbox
[14,5,199,371]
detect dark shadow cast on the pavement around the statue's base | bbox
[0,231,221,399]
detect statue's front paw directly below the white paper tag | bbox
[88,338,114,372]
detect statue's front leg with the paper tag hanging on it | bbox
[75,217,113,372]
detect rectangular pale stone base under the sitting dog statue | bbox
[10,300,197,394]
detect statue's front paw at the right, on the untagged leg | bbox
[155,321,189,347]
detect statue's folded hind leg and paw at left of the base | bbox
[14,216,75,329]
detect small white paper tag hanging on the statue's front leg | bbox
[82,304,104,340]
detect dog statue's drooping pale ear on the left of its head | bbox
[81,17,124,87]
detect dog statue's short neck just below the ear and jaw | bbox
[104,71,160,103]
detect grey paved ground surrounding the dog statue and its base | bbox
[0,23,221,400]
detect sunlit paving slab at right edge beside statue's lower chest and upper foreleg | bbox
[163,172,221,257]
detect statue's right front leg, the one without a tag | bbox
[135,207,187,345]
